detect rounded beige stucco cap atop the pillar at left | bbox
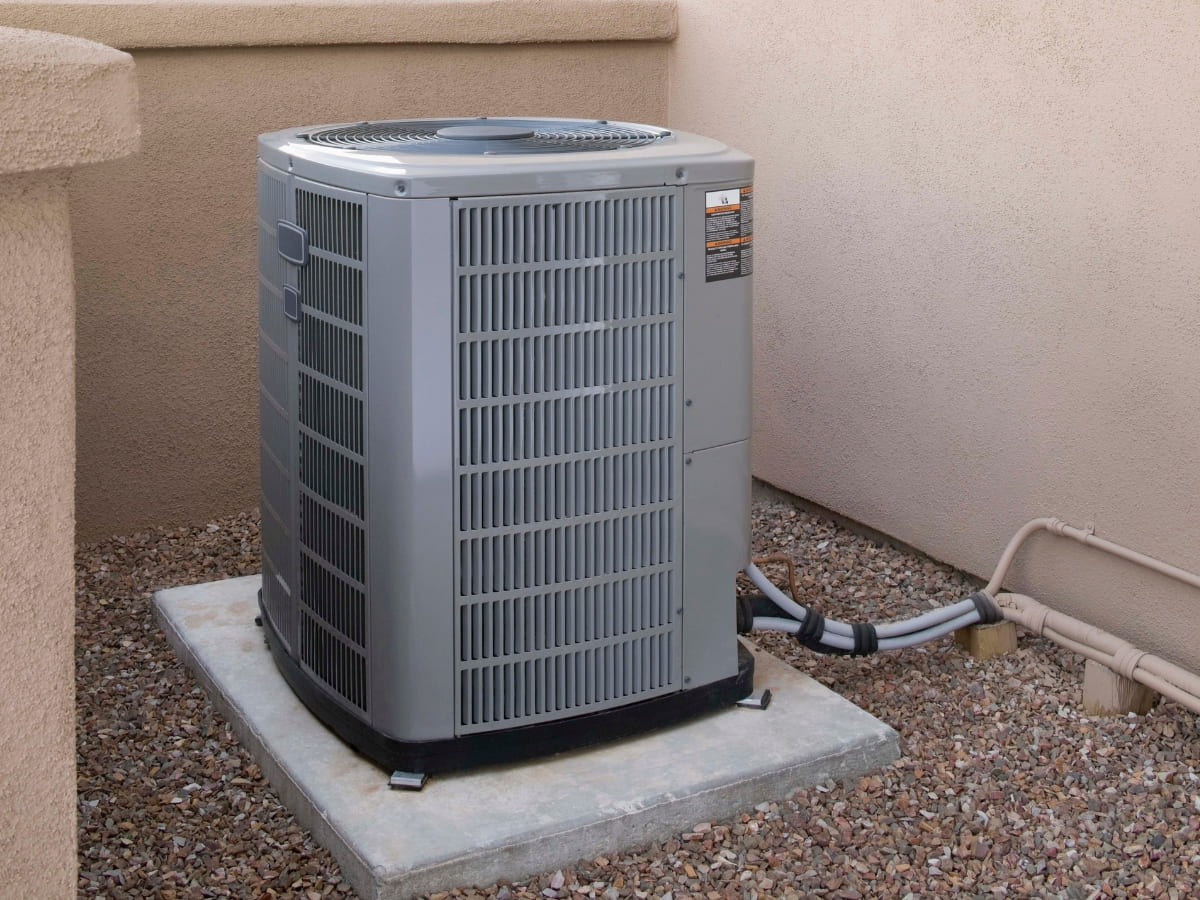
[0,28,140,174]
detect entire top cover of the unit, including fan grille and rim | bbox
[258,118,754,198]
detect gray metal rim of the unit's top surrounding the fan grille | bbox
[258,126,754,198]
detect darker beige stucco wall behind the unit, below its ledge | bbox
[44,24,673,540]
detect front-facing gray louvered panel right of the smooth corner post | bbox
[454,188,682,733]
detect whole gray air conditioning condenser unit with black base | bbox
[258,119,754,773]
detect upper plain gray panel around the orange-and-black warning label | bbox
[683,180,752,452]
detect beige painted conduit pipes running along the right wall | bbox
[984,518,1200,713]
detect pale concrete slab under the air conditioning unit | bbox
[155,576,898,900]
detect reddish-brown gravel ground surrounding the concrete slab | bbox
[77,498,1200,900]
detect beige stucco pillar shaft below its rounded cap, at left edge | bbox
[0,168,76,898]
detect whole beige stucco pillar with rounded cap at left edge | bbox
[0,28,138,898]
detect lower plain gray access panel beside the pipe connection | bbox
[683,440,750,688]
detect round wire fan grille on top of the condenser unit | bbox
[302,119,671,155]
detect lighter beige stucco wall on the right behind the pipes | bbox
[671,0,1200,668]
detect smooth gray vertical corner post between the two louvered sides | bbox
[366,197,454,740]
